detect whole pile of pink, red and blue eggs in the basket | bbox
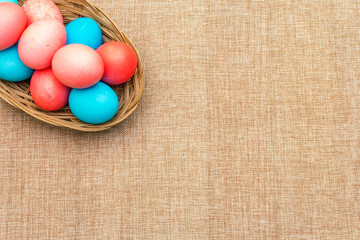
[0,0,137,124]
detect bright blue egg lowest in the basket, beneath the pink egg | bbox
[69,82,119,124]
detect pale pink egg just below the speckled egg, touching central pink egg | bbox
[19,19,66,69]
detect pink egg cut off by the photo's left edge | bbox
[0,2,26,50]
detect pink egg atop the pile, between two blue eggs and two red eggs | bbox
[52,44,104,88]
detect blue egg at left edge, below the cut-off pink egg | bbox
[0,43,35,82]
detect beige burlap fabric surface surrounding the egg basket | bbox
[0,0,360,240]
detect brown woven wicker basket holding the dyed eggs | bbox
[0,0,145,132]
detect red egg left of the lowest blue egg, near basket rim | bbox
[30,68,70,111]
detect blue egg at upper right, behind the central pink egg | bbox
[66,18,102,50]
